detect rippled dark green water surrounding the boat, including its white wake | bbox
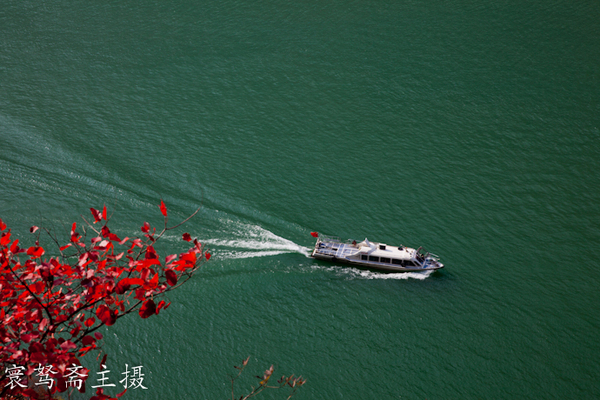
[0,0,600,399]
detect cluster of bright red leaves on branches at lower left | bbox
[0,200,210,399]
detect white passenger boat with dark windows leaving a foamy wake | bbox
[311,232,444,272]
